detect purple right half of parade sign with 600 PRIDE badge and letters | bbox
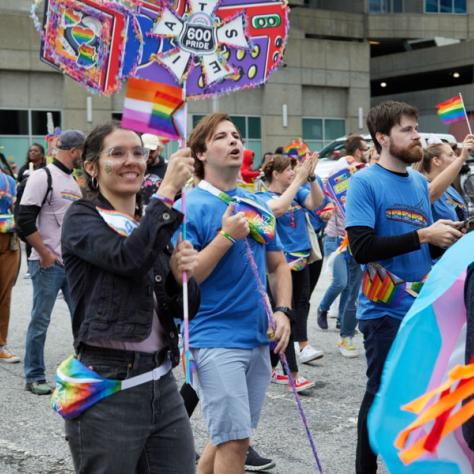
[149,0,288,98]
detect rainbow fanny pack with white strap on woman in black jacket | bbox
[51,356,171,420]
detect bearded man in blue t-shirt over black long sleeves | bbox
[346,101,462,474]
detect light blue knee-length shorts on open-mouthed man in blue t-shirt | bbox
[192,346,271,446]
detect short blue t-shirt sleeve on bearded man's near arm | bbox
[345,174,376,229]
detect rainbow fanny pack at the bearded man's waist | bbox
[362,263,428,306]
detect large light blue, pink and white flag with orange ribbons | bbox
[368,233,474,474]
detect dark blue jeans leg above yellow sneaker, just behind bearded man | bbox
[339,253,363,337]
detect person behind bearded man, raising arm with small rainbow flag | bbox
[419,135,474,221]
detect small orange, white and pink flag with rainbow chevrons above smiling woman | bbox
[122,78,185,140]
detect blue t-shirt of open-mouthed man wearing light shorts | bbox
[174,187,281,349]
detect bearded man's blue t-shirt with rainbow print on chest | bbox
[346,164,433,319]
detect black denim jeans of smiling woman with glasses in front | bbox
[66,346,195,474]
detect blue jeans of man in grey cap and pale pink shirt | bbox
[25,260,73,382]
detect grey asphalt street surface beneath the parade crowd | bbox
[0,252,386,474]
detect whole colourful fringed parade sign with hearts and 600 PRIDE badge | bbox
[32,0,289,98]
